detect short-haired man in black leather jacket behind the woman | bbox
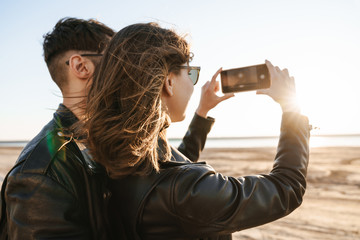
[0,18,232,240]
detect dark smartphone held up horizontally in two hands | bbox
[220,64,271,93]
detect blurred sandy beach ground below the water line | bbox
[0,147,360,240]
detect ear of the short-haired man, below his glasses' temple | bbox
[69,54,95,80]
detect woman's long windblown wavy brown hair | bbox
[84,23,190,178]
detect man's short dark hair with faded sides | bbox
[43,18,114,89]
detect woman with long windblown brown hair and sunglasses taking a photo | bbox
[86,24,309,239]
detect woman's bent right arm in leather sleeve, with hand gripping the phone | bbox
[172,62,310,235]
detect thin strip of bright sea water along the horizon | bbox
[0,134,360,148]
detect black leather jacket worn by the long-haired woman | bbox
[109,113,309,240]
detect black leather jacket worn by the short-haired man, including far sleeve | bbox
[0,105,213,240]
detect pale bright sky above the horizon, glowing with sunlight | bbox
[0,0,360,141]
